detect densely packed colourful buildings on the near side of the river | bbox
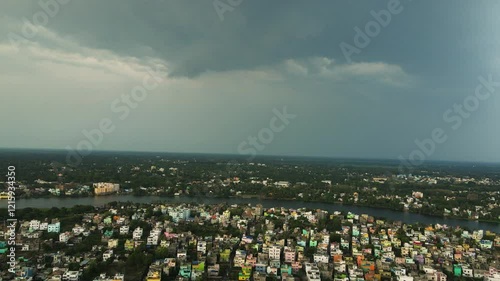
[0,202,500,281]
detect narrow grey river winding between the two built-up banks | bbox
[0,195,500,233]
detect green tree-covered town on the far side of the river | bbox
[0,153,500,223]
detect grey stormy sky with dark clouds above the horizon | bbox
[0,0,500,162]
